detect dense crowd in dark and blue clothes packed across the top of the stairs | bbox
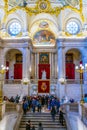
[23,95,60,114]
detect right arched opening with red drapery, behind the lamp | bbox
[65,49,82,79]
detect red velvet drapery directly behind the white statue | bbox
[38,64,50,79]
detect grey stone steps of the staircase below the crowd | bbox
[19,109,67,130]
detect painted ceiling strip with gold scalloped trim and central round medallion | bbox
[0,0,82,15]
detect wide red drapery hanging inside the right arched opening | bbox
[66,63,75,79]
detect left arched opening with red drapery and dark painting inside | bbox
[6,49,22,79]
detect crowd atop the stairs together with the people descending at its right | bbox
[23,95,64,125]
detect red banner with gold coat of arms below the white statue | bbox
[38,80,50,93]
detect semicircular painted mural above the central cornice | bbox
[33,30,56,46]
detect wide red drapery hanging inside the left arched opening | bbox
[14,64,22,79]
